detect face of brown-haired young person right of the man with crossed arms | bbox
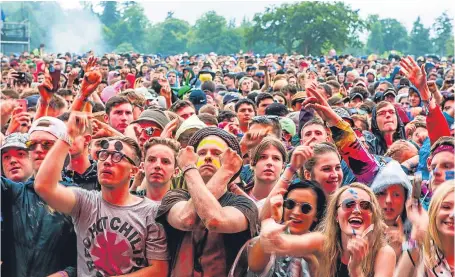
[254,146,284,182]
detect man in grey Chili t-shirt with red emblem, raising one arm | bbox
[35,113,168,276]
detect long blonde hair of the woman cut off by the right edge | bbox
[423,180,455,268]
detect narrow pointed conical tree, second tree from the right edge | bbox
[409,16,432,56]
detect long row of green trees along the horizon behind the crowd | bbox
[2,1,454,56]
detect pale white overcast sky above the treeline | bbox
[59,0,455,30]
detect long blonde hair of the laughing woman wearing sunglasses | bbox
[318,183,386,277]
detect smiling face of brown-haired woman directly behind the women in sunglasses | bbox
[311,152,343,195]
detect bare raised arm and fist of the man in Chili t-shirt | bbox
[35,113,88,214]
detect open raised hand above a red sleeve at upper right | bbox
[400,56,431,101]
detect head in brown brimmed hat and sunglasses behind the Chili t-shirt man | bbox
[131,109,170,149]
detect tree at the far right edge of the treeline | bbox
[433,12,453,56]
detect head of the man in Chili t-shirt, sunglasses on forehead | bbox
[97,140,138,190]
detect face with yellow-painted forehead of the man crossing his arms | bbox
[196,136,228,182]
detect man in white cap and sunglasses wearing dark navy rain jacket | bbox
[1,117,76,277]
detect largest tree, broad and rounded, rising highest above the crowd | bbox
[249,2,364,55]
